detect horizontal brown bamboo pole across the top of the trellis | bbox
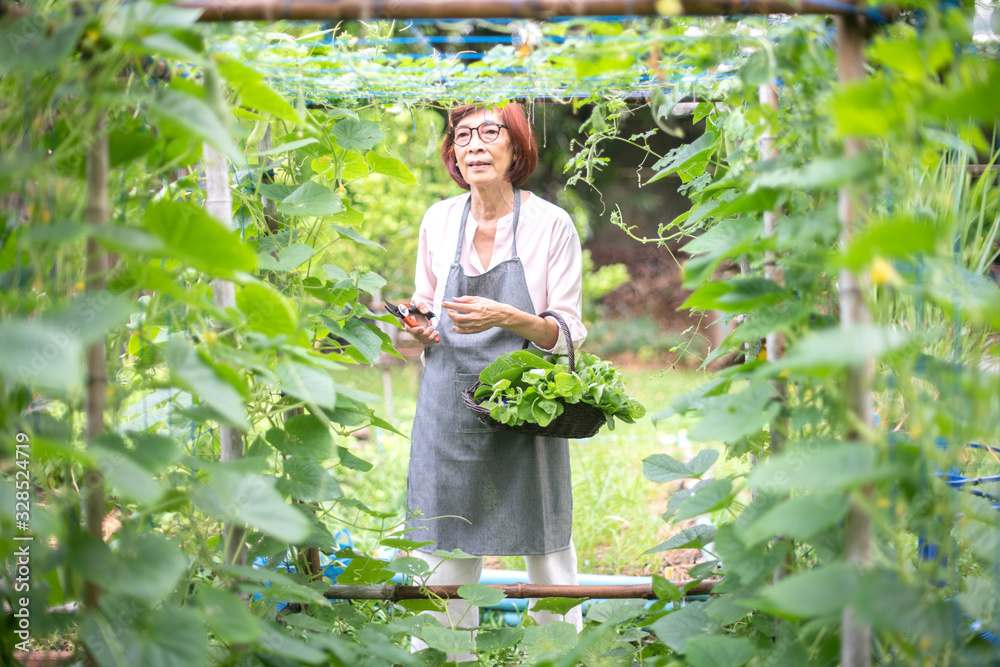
[182,0,898,21]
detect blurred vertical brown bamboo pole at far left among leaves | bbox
[83,111,111,666]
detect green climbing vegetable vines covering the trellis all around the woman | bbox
[0,2,1000,667]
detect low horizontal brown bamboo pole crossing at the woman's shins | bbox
[323,581,715,602]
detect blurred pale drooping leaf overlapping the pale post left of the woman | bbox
[166,338,250,429]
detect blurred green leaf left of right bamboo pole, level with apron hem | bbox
[742,493,848,547]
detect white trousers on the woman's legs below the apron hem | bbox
[410,538,583,662]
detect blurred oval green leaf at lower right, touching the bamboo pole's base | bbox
[755,562,860,619]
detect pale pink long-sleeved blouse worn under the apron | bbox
[414,194,587,354]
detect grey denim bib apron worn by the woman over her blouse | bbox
[406,188,573,556]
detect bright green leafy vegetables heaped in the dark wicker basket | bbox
[475,350,646,430]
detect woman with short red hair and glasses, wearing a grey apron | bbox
[398,104,587,648]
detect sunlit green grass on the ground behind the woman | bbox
[332,364,716,574]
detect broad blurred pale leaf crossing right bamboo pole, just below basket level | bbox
[747,438,884,494]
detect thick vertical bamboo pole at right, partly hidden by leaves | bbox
[837,16,874,667]
